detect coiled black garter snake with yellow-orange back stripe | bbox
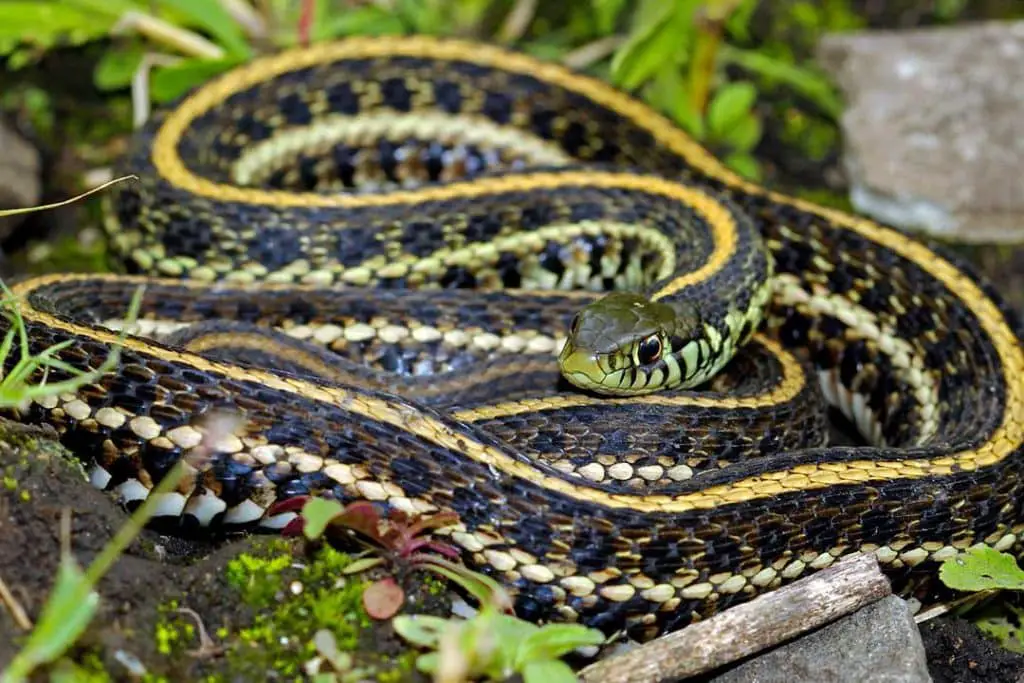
[2,37,1024,638]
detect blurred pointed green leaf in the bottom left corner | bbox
[5,555,99,680]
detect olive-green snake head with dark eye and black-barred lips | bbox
[558,292,702,396]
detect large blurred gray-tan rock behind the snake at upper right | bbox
[818,22,1024,242]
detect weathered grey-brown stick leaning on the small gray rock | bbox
[580,553,892,683]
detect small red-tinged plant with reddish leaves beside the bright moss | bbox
[269,496,512,620]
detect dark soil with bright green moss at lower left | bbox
[0,421,436,681]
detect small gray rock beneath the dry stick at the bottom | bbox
[709,596,932,683]
